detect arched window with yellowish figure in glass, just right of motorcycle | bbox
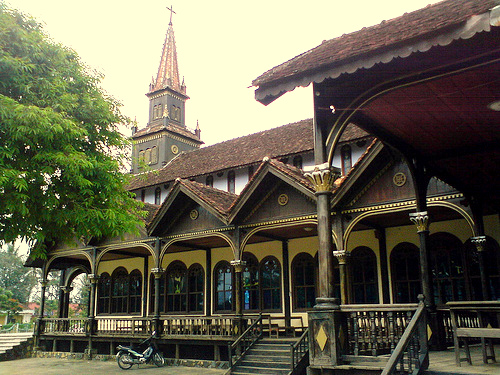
[166,261,187,312]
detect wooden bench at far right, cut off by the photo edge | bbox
[447,301,500,366]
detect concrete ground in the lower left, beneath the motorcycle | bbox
[0,358,227,375]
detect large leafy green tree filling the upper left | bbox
[0,0,143,257]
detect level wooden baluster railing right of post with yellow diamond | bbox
[340,304,418,356]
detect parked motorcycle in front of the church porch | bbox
[116,331,165,370]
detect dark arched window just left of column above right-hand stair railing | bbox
[391,242,422,303]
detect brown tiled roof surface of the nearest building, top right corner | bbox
[252,0,498,87]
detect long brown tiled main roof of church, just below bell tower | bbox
[128,119,314,190]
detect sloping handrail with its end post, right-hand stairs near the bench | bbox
[382,295,428,375]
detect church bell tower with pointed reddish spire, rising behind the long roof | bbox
[132,8,203,174]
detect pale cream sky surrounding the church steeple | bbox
[4,0,436,145]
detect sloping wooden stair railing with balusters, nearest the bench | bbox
[382,296,429,375]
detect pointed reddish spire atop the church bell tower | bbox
[150,8,186,93]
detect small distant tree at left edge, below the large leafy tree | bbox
[0,244,37,303]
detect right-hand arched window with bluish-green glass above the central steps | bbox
[260,256,281,310]
